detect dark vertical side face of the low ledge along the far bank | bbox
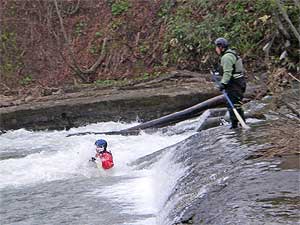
[0,91,216,130]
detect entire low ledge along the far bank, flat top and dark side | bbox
[0,71,219,131]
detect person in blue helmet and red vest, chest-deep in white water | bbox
[92,139,114,170]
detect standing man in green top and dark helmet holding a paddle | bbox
[215,38,246,129]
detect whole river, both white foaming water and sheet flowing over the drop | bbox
[0,113,300,225]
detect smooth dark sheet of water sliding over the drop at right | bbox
[137,121,300,225]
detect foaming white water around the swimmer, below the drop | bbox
[0,122,196,225]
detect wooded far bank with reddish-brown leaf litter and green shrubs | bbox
[0,0,300,93]
